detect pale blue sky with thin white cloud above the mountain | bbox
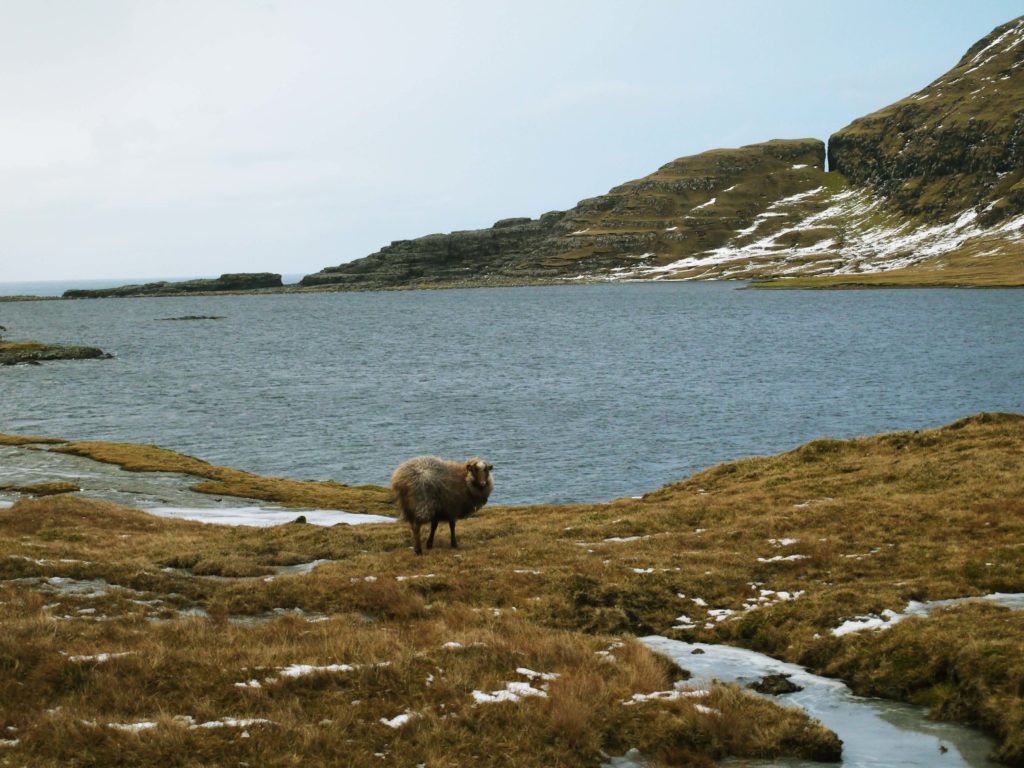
[0,0,1024,282]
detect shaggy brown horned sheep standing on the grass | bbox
[391,456,495,555]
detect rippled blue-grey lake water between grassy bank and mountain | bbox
[0,283,1024,504]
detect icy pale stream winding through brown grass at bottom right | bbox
[641,635,998,768]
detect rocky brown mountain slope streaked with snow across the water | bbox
[302,16,1024,288]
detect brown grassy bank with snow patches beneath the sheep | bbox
[0,415,1024,766]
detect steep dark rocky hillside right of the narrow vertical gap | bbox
[828,18,1024,224]
